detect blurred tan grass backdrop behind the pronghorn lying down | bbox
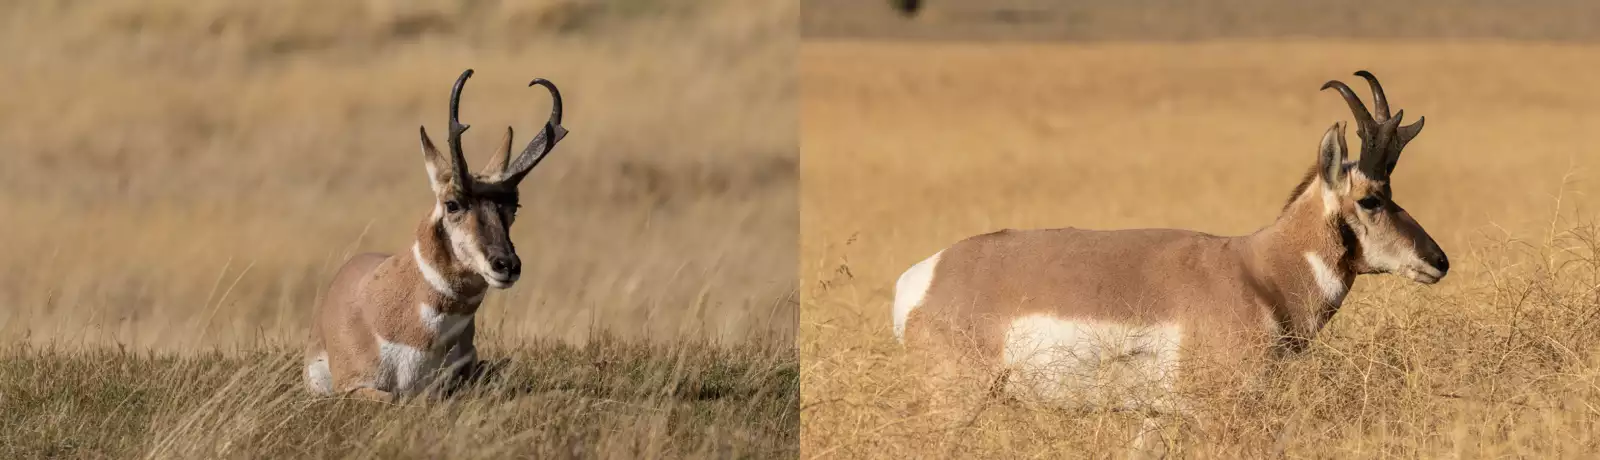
[0,0,797,348]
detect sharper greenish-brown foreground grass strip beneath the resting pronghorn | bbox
[0,337,800,458]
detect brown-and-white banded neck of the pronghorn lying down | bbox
[408,217,488,315]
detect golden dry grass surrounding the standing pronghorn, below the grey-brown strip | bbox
[800,40,1600,458]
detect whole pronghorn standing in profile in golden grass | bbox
[893,70,1450,447]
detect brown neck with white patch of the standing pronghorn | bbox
[1246,167,1357,345]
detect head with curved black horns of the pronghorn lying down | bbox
[419,69,566,289]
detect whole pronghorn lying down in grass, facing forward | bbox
[306,69,566,399]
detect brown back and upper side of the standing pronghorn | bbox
[896,228,1261,351]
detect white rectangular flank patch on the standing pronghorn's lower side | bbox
[1003,315,1182,410]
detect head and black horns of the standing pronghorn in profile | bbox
[1317,70,1450,284]
